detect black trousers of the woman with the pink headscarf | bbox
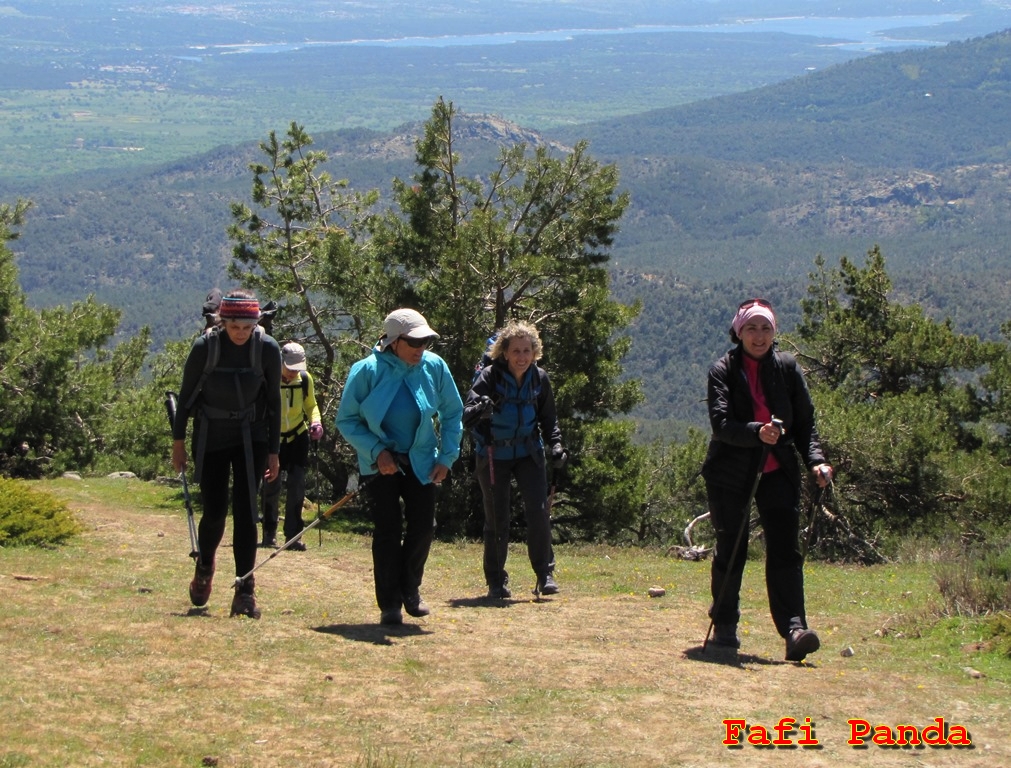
[706,470,807,638]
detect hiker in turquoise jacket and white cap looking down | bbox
[337,309,463,625]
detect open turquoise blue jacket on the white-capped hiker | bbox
[337,348,463,483]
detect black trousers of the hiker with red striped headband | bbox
[197,443,267,576]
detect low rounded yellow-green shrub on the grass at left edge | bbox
[0,477,83,547]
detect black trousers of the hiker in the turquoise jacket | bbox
[365,467,436,610]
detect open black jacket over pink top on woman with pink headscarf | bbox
[702,345,825,488]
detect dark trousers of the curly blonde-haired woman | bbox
[474,456,555,587]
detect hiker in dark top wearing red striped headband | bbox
[172,290,281,618]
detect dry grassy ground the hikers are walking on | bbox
[0,480,1011,768]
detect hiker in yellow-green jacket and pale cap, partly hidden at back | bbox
[260,342,323,552]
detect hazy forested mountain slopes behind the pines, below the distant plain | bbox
[0,33,1011,435]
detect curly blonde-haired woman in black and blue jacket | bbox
[463,321,568,599]
